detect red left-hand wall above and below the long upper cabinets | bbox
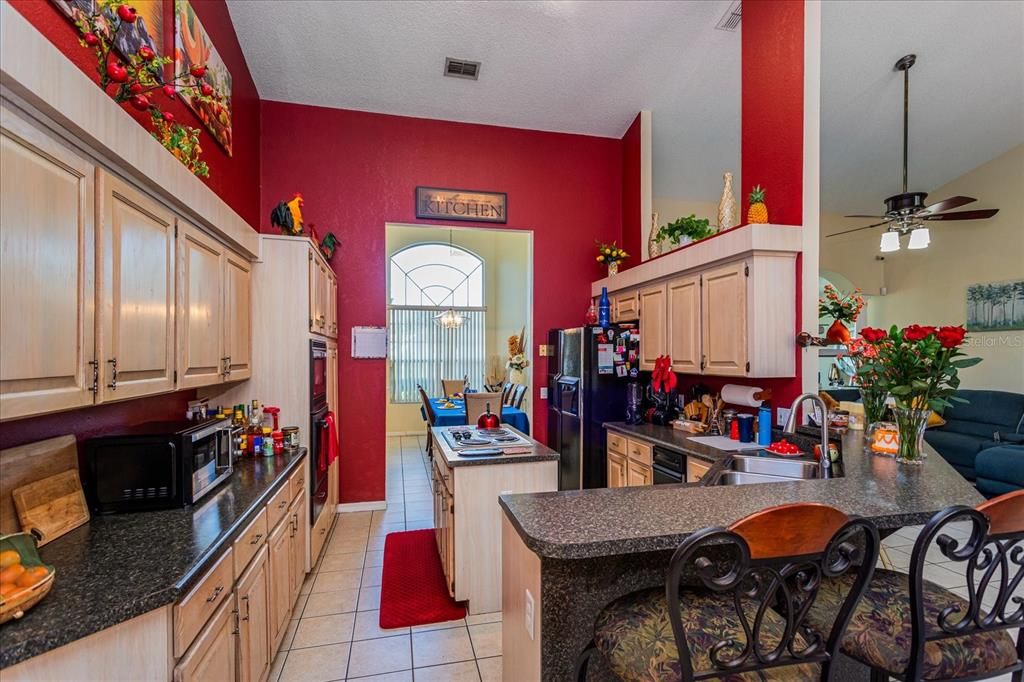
[0,0,260,449]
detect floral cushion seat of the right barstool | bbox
[807,568,1017,680]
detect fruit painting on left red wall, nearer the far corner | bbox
[174,0,231,156]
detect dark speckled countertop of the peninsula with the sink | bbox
[499,423,983,559]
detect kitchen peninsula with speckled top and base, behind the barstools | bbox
[500,423,983,680]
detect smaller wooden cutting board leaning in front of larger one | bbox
[11,468,89,546]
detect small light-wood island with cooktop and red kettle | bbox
[431,424,558,613]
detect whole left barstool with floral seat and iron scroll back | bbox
[577,503,879,682]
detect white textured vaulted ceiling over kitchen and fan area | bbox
[228,0,1024,213]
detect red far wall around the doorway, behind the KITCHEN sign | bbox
[260,101,622,502]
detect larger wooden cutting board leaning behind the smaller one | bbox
[0,435,89,540]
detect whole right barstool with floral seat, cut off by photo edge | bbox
[808,491,1024,682]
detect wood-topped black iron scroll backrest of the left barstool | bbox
[666,503,879,682]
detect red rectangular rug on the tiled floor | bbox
[380,528,466,628]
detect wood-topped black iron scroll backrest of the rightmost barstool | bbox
[905,491,1024,680]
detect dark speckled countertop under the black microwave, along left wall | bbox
[0,449,306,668]
